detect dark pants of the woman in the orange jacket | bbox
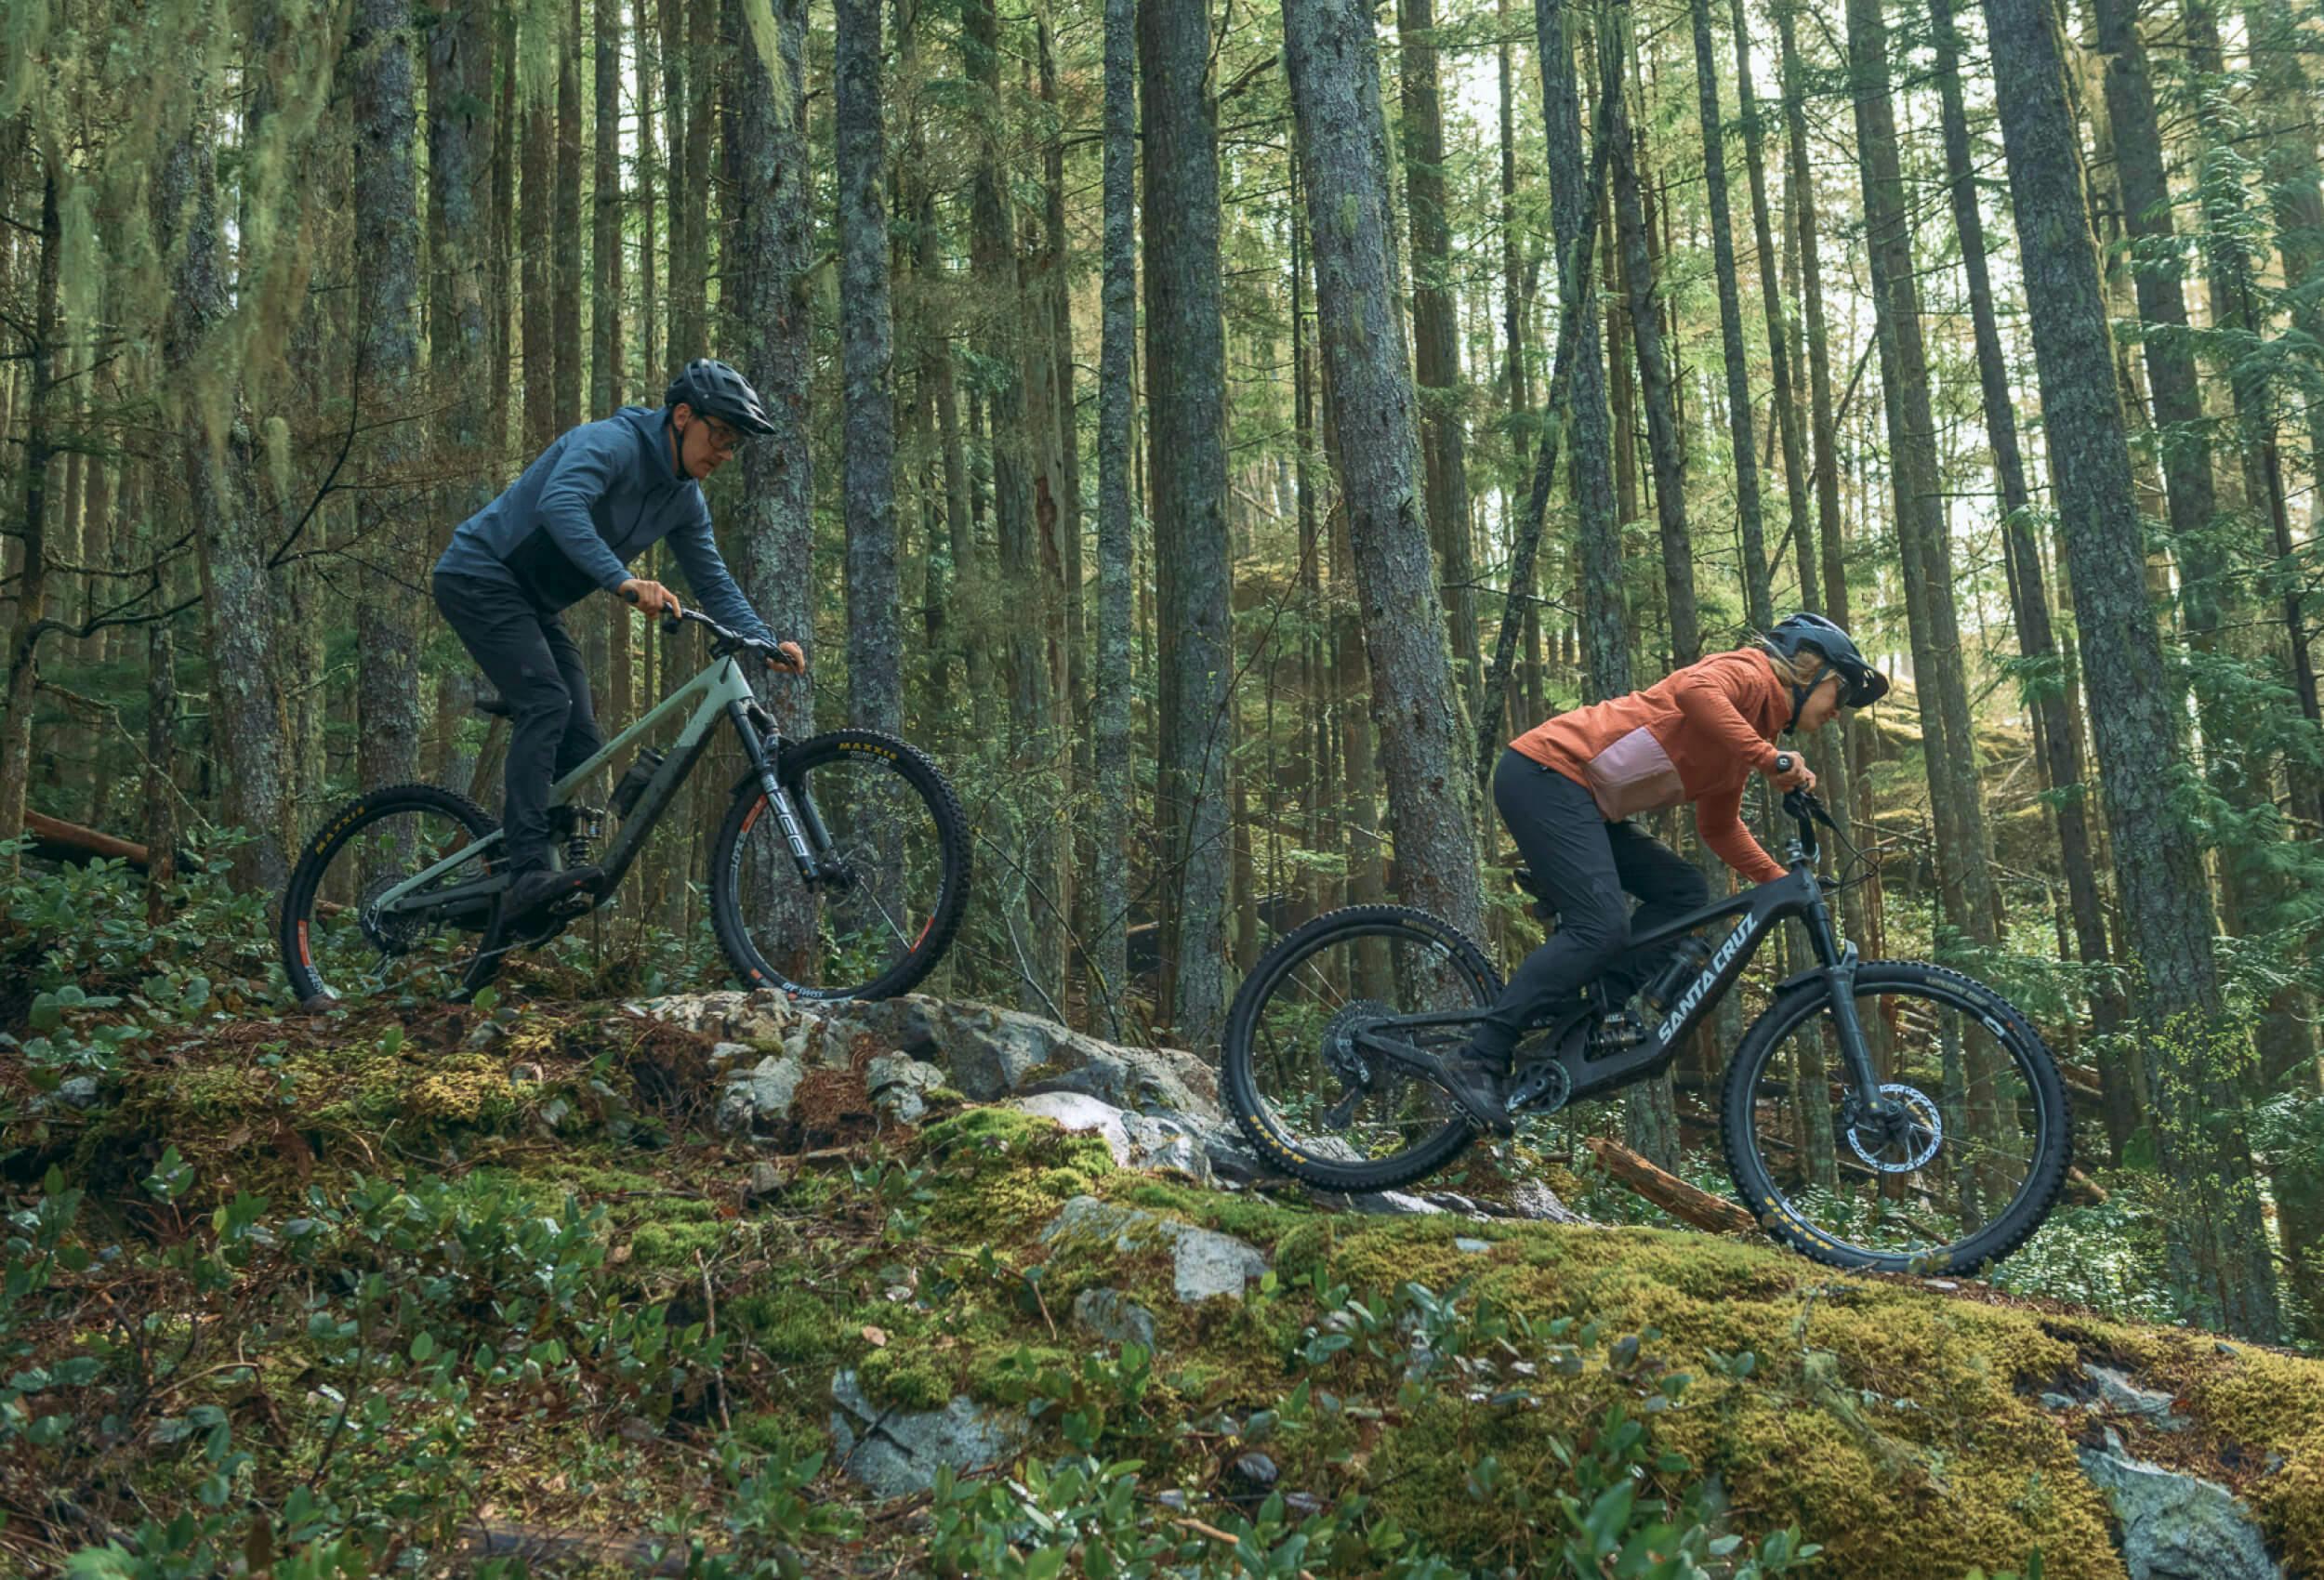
[1472,751,1710,1060]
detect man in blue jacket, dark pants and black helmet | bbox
[435,358,807,918]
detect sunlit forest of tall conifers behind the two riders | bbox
[0,0,2324,1343]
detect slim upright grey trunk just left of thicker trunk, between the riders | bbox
[1090,0,1148,1041]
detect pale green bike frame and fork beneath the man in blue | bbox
[379,653,830,914]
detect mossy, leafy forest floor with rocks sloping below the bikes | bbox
[0,1004,2324,1580]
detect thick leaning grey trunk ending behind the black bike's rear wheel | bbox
[1283,0,1483,953]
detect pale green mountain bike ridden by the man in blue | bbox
[282,609,970,1007]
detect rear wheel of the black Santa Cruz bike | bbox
[1225,906,1501,1190]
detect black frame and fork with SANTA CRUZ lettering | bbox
[1355,823,1887,1115]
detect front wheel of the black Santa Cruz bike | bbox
[1723,960,2073,1276]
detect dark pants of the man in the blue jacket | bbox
[435,576,604,872]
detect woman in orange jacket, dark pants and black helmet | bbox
[1444,613,1890,1134]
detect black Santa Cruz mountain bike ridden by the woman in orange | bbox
[1225,771,2073,1273]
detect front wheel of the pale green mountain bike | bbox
[711,730,970,999]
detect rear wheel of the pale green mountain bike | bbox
[279,785,500,1008]
